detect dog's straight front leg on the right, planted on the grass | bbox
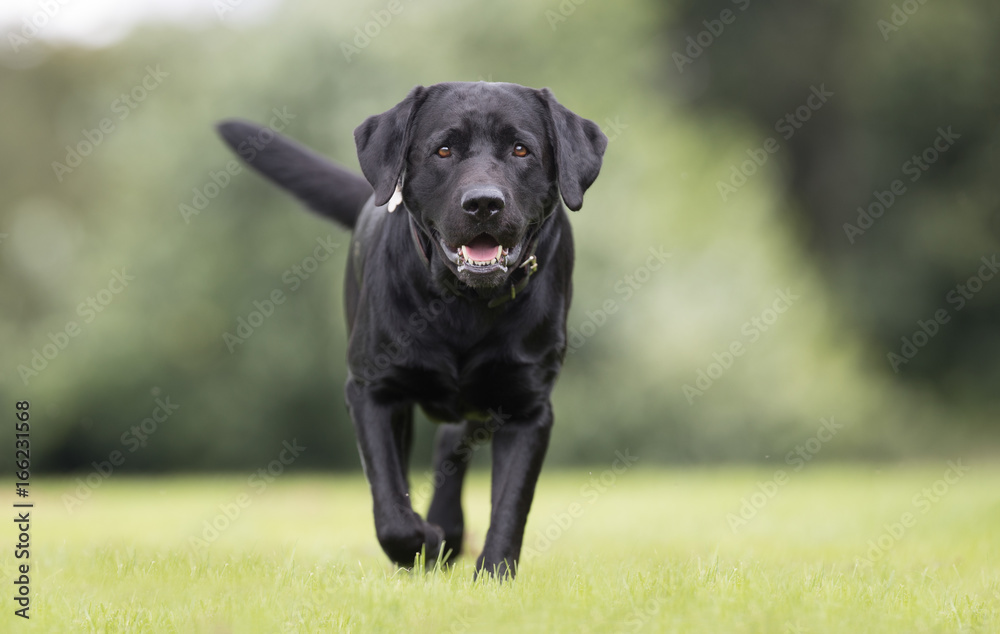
[476,403,552,577]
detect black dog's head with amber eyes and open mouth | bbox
[354,82,607,288]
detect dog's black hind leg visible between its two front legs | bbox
[427,423,474,559]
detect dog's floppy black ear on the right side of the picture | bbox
[539,88,608,211]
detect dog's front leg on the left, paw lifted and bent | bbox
[345,380,444,567]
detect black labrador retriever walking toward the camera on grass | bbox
[219,82,607,575]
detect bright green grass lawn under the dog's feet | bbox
[0,463,1000,634]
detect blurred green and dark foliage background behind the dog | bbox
[0,0,1000,472]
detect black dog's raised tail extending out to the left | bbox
[216,119,373,229]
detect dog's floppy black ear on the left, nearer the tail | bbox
[354,86,427,205]
